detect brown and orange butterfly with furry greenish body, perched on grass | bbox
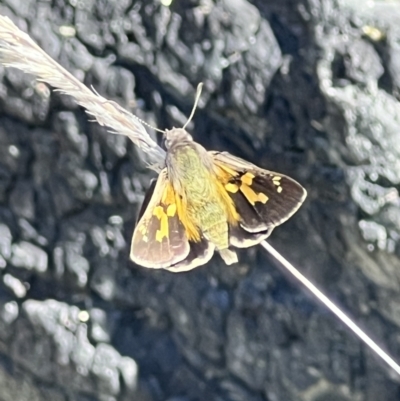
[130,126,307,272]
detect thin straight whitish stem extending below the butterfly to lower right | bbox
[261,241,400,375]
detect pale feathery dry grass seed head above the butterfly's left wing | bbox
[0,15,165,170]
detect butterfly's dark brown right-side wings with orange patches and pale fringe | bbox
[210,152,307,248]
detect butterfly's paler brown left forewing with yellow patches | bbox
[130,169,190,269]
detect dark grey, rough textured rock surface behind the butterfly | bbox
[0,0,400,401]
